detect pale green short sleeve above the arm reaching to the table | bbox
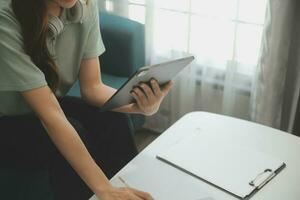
[0,14,47,91]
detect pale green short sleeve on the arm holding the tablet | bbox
[83,1,105,59]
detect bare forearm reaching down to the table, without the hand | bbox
[42,111,111,194]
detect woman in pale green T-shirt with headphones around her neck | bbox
[0,0,172,200]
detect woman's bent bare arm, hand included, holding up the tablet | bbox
[79,58,172,115]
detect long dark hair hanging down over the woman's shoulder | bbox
[12,0,59,92]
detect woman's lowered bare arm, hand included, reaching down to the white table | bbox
[22,87,152,200]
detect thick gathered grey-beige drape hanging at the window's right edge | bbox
[252,0,299,128]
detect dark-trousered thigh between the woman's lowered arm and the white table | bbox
[59,97,137,177]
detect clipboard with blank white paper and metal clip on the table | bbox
[156,130,286,199]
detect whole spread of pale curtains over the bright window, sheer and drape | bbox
[100,0,298,132]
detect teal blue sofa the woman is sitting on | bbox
[0,13,145,200]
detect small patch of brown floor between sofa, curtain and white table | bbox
[135,129,160,152]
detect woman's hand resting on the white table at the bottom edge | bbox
[97,188,154,200]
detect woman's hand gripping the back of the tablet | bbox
[131,79,173,116]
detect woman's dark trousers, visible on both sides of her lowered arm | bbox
[0,97,137,200]
